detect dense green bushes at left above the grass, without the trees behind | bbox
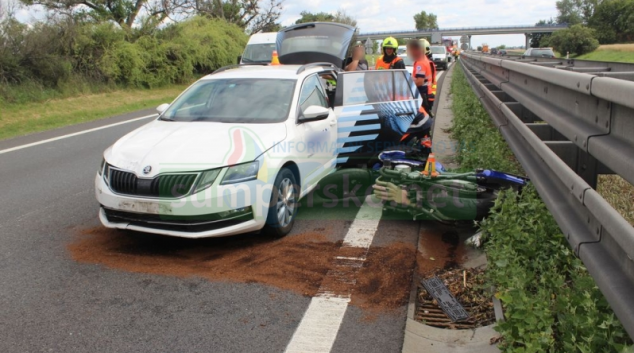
[0,17,247,104]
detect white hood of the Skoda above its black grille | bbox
[104,120,286,177]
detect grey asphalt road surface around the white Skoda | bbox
[0,64,450,353]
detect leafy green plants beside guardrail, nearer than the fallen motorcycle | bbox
[481,185,632,353]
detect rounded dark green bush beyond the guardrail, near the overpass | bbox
[544,25,599,55]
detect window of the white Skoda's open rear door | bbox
[342,71,392,105]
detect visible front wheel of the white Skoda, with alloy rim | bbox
[264,168,299,238]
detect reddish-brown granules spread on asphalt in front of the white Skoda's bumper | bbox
[68,227,341,296]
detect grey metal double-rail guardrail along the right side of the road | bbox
[460,53,634,337]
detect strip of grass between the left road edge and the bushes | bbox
[0,85,187,140]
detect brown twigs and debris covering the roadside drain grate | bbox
[414,268,495,330]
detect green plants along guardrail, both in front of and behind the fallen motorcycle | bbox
[451,65,632,352]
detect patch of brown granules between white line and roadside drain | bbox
[352,243,416,310]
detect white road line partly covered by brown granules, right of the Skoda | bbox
[286,196,382,353]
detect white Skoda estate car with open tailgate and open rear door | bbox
[95,23,421,238]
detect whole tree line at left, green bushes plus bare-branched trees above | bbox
[0,0,282,104]
